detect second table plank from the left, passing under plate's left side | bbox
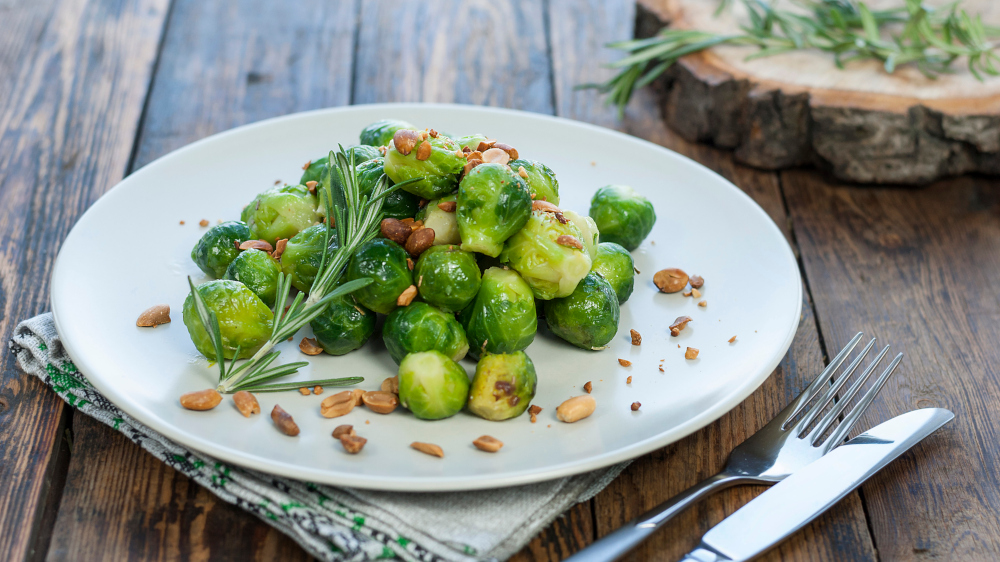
[50,0,357,560]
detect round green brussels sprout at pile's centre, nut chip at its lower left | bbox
[413,245,480,312]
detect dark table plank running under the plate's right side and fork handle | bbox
[549,0,875,560]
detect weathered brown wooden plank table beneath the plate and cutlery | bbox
[0,0,1000,560]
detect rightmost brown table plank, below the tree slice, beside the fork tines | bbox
[782,171,1000,560]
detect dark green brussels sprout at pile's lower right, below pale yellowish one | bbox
[545,273,621,350]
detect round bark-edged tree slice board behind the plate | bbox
[636,0,1000,184]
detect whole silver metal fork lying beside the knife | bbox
[567,332,903,562]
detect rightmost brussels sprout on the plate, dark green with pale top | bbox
[590,185,656,252]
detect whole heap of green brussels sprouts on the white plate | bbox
[183,120,656,420]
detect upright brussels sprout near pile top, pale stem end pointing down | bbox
[457,164,531,258]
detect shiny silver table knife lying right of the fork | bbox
[681,408,955,562]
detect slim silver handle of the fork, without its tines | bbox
[566,472,749,562]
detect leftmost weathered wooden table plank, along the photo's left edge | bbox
[0,0,167,560]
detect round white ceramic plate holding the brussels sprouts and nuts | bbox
[52,105,802,491]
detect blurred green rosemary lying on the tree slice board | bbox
[579,0,1000,116]
